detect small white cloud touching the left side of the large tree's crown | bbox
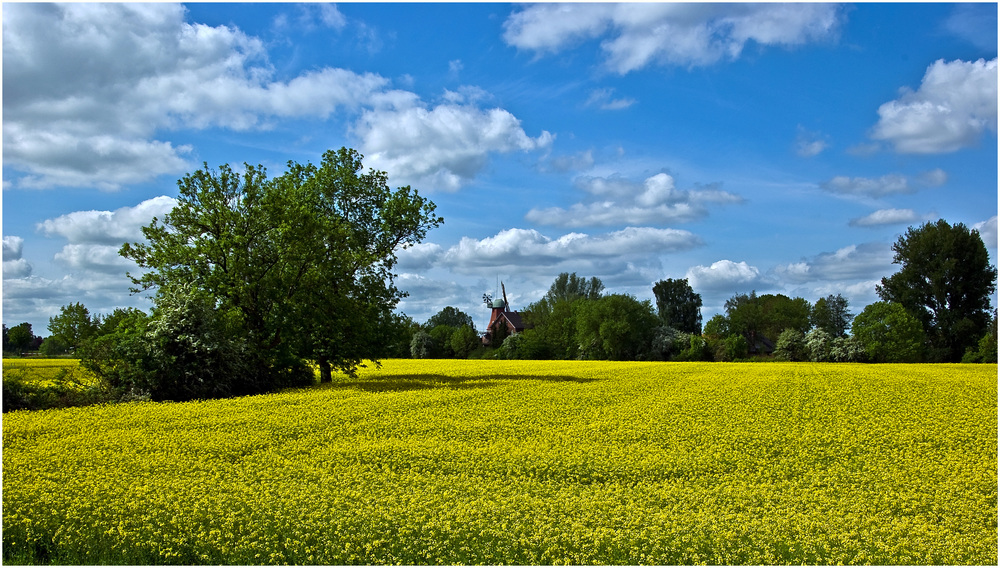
[38,195,177,245]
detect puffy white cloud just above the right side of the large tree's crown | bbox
[354,99,553,191]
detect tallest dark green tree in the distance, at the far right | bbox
[876,219,997,362]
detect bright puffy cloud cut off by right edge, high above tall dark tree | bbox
[871,59,997,154]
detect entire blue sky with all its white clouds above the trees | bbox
[2,3,998,335]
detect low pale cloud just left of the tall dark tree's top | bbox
[774,243,893,283]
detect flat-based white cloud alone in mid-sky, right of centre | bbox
[525,173,743,227]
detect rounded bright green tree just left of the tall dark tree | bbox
[851,302,924,363]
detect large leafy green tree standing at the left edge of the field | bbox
[120,148,443,388]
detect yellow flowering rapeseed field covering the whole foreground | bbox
[3,360,997,565]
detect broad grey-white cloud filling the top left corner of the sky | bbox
[3,3,387,190]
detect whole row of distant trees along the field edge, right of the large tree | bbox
[411,220,997,363]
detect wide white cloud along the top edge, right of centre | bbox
[503,3,840,75]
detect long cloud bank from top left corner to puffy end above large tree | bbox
[3,4,553,190]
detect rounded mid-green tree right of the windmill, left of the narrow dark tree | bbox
[576,294,659,361]
